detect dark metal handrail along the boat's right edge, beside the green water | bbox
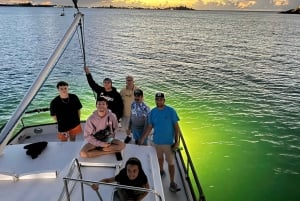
[178,132,206,201]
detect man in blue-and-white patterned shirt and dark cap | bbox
[125,89,150,145]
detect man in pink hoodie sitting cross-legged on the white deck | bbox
[80,97,125,158]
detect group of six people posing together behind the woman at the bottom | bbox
[50,67,180,200]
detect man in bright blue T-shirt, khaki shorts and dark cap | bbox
[139,92,180,192]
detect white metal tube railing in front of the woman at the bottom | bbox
[59,159,162,201]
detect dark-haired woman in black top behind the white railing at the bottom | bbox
[92,157,149,201]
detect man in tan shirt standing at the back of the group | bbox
[120,75,137,143]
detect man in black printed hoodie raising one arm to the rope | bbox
[84,66,124,121]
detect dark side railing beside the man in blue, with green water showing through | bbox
[176,130,206,201]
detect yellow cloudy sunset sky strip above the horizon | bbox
[0,0,300,11]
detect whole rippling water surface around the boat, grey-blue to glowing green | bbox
[0,8,300,201]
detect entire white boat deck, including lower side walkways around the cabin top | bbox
[0,125,195,201]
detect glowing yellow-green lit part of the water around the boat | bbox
[17,88,300,201]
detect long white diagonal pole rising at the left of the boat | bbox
[0,12,83,155]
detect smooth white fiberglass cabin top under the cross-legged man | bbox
[0,141,163,201]
